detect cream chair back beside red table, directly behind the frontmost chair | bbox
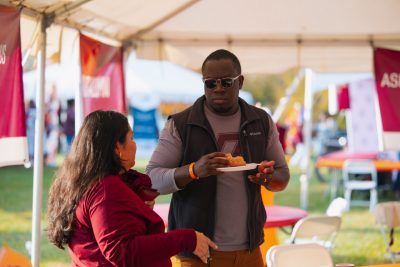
[286,215,342,250]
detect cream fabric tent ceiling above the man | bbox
[0,0,400,73]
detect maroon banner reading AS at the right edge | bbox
[374,48,400,150]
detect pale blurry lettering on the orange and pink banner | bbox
[82,76,111,98]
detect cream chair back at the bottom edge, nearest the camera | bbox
[266,244,334,267]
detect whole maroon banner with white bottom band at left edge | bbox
[0,6,29,167]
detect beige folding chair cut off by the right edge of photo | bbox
[375,202,400,263]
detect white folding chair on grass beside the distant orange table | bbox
[343,159,378,212]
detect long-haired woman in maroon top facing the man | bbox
[48,111,216,267]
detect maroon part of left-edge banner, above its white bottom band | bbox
[0,6,26,138]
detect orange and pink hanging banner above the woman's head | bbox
[80,34,126,116]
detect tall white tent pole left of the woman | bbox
[31,15,47,267]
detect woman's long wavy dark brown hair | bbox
[47,110,130,249]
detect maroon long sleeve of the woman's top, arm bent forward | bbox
[89,181,196,266]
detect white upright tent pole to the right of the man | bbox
[300,68,313,209]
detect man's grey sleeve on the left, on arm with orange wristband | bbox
[146,119,182,194]
